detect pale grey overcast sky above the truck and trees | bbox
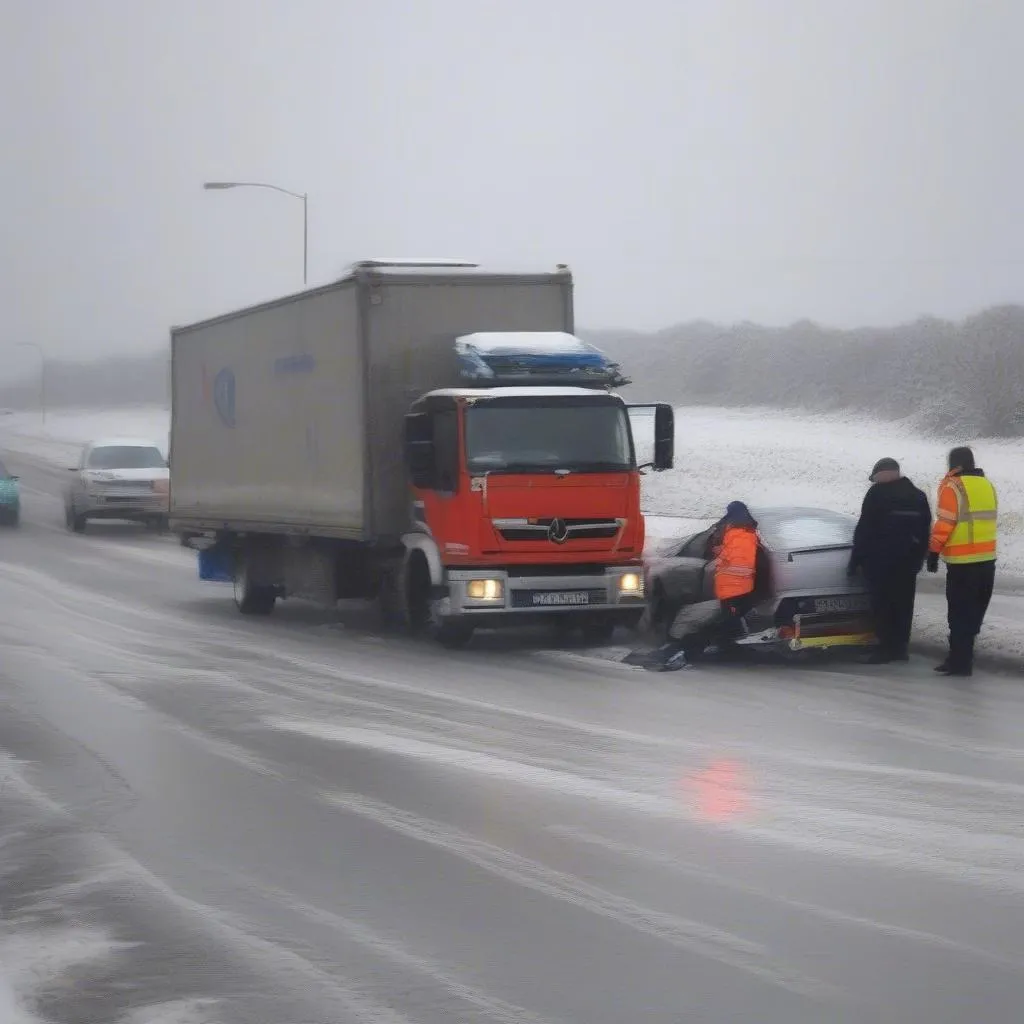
[0,0,1024,372]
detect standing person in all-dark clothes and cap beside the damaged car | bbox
[849,459,932,665]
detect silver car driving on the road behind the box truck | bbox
[65,438,170,534]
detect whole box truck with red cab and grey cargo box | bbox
[170,261,672,643]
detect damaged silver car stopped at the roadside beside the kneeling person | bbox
[644,508,877,651]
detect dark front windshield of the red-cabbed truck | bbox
[466,401,635,473]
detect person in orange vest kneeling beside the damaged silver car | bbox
[644,502,758,672]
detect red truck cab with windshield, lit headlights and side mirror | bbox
[402,387,674,642]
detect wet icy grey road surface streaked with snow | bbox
[0,457,1024,1024]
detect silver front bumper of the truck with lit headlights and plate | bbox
[437,565,644,625]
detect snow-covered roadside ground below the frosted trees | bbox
[0,407,1024,663]
